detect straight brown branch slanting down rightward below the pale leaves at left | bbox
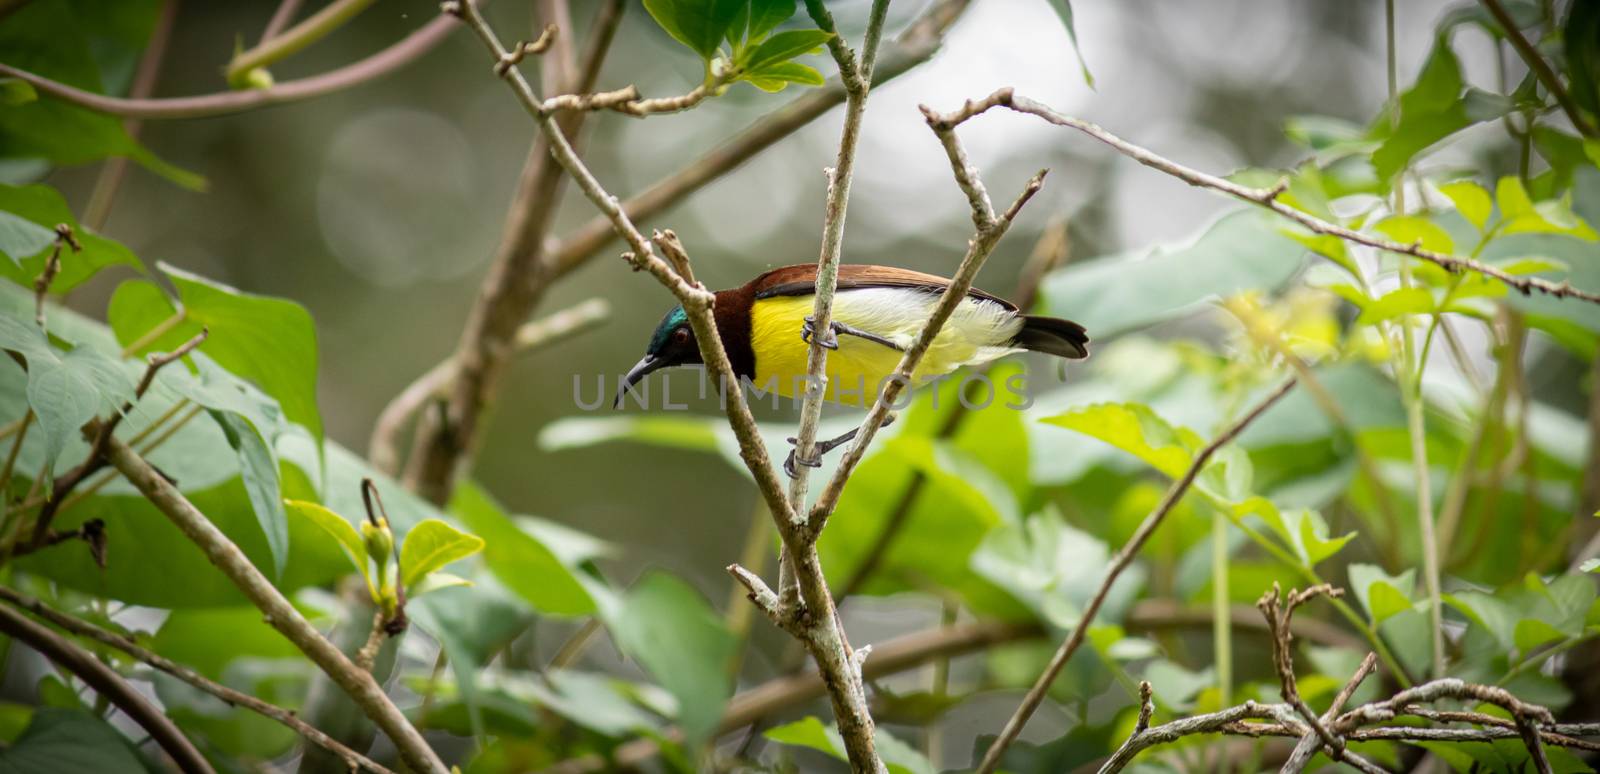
[96,437,448,774]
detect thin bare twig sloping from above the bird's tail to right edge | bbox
[950,88,1600,304]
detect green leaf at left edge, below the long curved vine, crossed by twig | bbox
[0,183,144,294]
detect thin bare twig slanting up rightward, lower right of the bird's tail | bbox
[978,379,1299,774]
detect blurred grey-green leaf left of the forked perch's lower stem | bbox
[606,573,738,747]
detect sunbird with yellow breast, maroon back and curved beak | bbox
[614,264,1090,477]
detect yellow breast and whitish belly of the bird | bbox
[750,288,1022,406]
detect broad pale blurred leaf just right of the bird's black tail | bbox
[1040,209,1306,339]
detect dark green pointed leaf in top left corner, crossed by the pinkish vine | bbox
[0,2,205,190]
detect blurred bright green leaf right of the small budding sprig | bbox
[450,485,595,616]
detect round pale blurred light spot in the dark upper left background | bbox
[317,107,491,286]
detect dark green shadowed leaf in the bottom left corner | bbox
[0,707,162,774]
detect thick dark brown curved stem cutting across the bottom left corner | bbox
[0,606,213,774]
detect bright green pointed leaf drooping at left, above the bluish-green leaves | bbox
[107,264,323,443]
